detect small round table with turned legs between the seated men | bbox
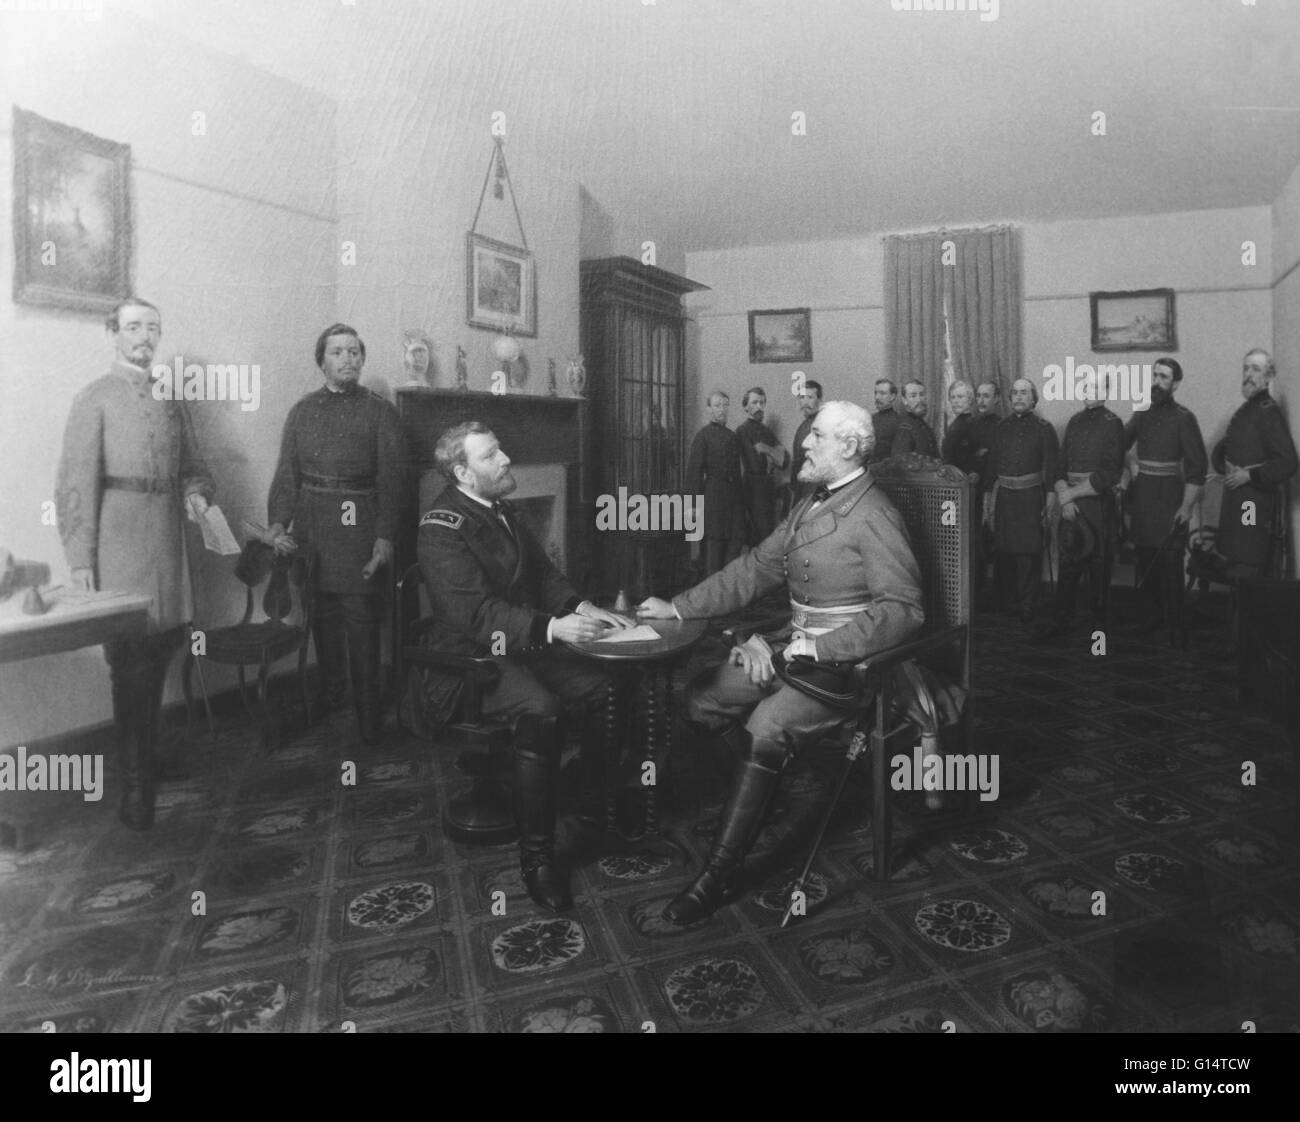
[566,619,709,837]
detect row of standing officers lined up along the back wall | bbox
[688,348,1296,647]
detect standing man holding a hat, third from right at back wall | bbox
[1036,382,1125,638]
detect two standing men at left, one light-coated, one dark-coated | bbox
[55,296,400,829]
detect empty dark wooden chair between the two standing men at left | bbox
[181,540,312,750]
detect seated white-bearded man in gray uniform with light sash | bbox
[637,402,923,924]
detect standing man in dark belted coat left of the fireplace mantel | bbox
[267,324,402,745]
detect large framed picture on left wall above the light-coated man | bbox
[13,105,131,312]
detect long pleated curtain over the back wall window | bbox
[884,226,1022,436]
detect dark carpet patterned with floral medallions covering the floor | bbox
[0,592,1300,1032]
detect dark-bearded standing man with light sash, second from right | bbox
[1125,359,1209,646]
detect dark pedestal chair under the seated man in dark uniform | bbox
[394,564,519,845]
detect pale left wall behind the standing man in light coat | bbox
[0,13,337,748]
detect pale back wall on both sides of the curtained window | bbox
[686,209,1274,491]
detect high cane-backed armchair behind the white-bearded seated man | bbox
[733,452,974,926]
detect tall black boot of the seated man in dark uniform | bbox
[515,716,573,911]
